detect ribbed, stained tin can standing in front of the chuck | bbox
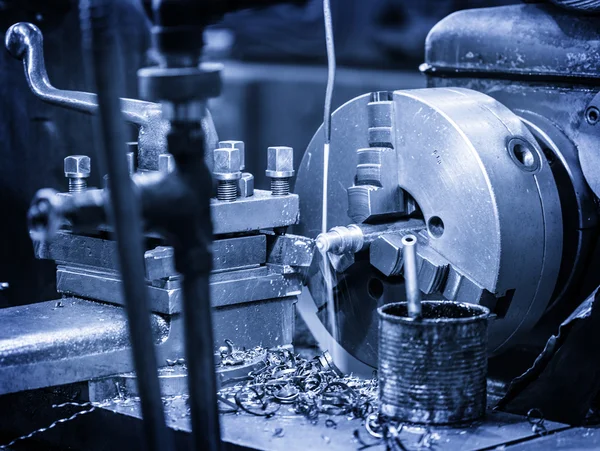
[378,301,489,424]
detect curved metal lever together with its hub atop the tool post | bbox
[5,22,218,171]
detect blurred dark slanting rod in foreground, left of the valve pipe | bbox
[80,0,172,451]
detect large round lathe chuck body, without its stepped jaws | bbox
[296,89,562,366]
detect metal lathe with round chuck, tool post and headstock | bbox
[0,2,600,449]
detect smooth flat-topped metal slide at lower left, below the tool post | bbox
[0,298,169,393]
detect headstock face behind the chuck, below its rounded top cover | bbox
[429,81,600,314]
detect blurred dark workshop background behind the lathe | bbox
[0,0,517,307]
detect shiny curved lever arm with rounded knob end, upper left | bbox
[5,22,160,125]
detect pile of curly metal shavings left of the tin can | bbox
[218,344,378,427]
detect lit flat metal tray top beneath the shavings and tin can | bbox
[91,400,568,451]
